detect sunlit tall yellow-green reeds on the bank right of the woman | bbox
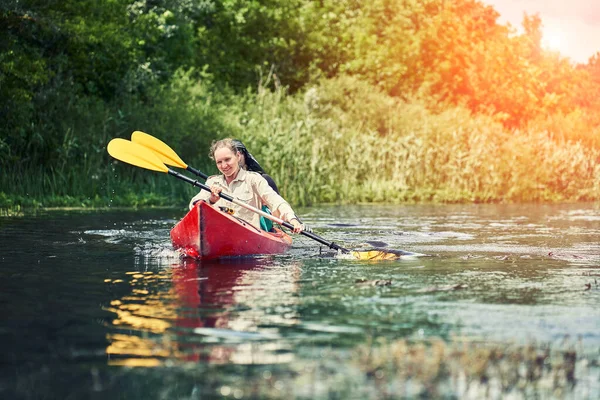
[220,78,600,204]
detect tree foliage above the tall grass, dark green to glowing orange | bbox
[0,0,600,206]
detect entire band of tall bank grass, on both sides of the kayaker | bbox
[0,72,600,208]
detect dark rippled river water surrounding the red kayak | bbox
[0,204,600,399]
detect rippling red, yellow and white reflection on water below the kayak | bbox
[107,258,300,366]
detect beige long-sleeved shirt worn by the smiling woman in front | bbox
[189,168,296,228]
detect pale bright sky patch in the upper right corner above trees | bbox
[480,0,600,63]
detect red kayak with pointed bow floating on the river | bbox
[171,201,292,260]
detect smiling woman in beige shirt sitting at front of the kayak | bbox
[190,138,304,233]
